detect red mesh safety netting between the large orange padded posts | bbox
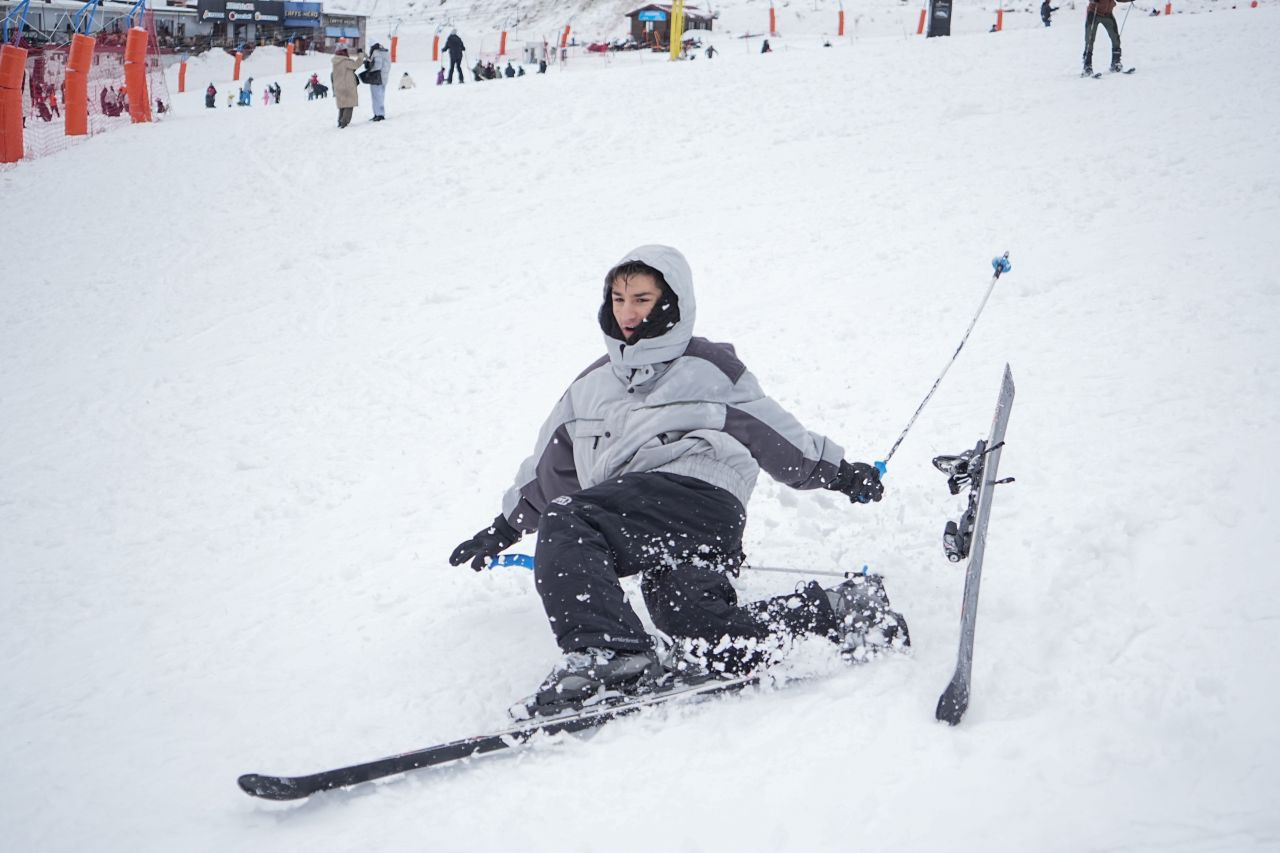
[22,12,173,160]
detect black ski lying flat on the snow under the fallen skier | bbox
[237,675,762,800]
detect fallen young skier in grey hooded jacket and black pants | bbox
[449,246,910,716]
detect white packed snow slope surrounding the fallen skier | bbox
[0,8,1280,853]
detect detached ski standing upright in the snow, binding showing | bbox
[933,364,1014,726]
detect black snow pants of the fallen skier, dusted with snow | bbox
[535,473,837,671]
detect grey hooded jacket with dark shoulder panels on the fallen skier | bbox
[502,246,844,533]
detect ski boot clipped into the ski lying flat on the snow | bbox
[511,648,663,720]
